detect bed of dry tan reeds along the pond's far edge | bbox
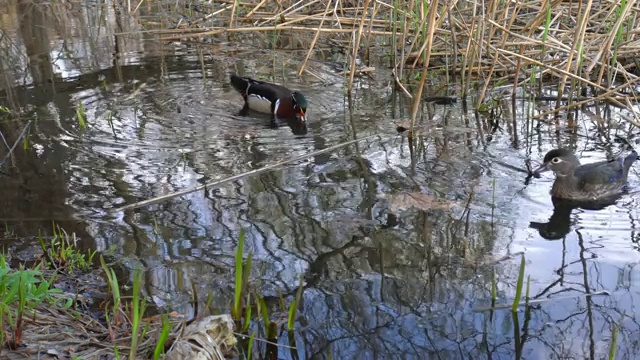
[145,0,640,115]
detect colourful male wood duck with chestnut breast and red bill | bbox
[231,74,307,122]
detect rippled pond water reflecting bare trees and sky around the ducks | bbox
[0,1,640,359]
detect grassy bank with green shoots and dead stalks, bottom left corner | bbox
[0,225,184,359]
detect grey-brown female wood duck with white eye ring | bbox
[534,149,638,201]
